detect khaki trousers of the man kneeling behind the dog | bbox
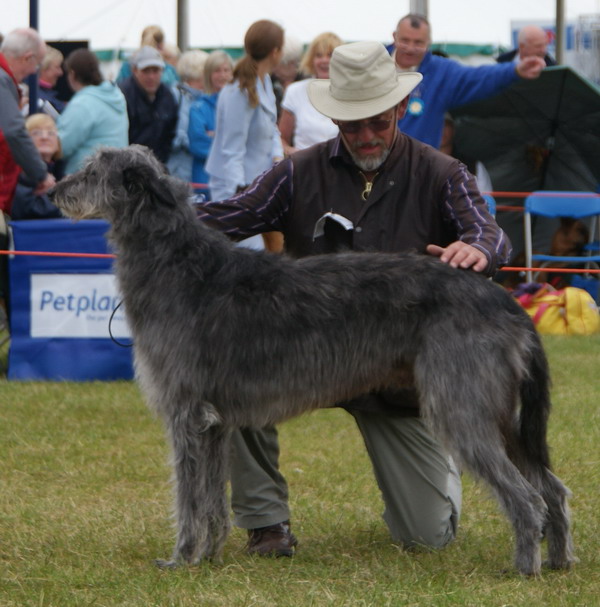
[231,411,462,548]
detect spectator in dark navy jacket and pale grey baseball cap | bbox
[119,46,178,163]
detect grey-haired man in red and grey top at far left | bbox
[0,28,55,215]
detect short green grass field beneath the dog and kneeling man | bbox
[0,336,600,607]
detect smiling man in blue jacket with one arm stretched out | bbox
[388,14,546,148]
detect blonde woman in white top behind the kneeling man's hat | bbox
[279,32,342,156]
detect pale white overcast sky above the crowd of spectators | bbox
[0,0,600,50]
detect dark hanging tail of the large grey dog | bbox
[519,329,551,469]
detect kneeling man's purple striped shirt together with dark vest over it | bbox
[197,133,510,275]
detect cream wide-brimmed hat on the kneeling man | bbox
[308,42,423,120]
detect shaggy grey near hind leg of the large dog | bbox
[415,342,547,575]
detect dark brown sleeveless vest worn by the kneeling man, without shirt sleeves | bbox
[285,133,459,257]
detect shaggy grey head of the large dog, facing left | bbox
[49,145,190,223]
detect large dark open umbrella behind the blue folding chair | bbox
[452,66,600,252]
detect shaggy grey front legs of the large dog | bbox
[157,408,229,567]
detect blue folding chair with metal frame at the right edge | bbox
[525,191,600,282]
